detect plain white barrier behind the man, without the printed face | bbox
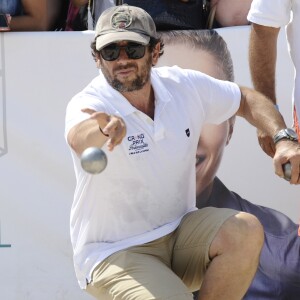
[0,27,300,300]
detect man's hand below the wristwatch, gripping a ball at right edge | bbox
[273,140,300,184]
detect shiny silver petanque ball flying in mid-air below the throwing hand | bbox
[81,147,107,174]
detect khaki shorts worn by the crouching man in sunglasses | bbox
[87,207,237,300]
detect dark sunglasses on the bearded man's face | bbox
[100,42,146,61]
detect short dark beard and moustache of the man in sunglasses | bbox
[101,56,152,93]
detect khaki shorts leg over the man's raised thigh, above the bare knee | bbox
[172,207,238,291]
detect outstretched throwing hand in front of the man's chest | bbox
[82,108,126,151]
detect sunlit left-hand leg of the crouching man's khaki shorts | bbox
[87,235,193,300]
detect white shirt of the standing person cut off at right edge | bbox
[248,0,300,124]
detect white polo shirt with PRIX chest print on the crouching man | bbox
[65,67,241,288]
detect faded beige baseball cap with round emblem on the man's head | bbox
[95,4,157,50]
